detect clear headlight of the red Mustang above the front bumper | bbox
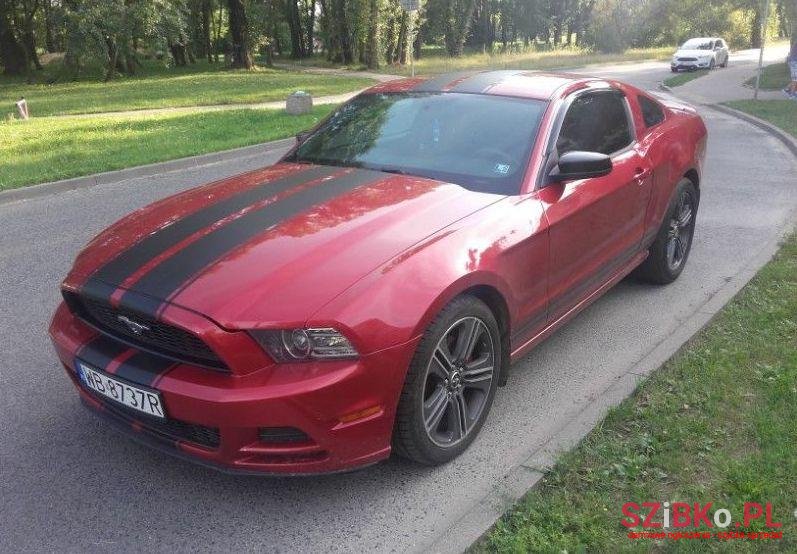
[249,328,357,362]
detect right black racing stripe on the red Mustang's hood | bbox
[121,169,386,317]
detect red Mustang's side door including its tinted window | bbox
[538,89,651,321]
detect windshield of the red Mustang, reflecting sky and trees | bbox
[288,93,546,194]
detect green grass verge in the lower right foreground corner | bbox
[473,231,797,552]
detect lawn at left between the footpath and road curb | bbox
[0,105,334,190]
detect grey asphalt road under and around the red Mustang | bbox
[0,61,797,552]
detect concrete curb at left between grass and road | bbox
[0,138,295,205]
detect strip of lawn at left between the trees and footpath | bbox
[0,62,374,117]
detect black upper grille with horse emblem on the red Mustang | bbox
[64,291,227,370]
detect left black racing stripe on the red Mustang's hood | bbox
[84,167,336,299]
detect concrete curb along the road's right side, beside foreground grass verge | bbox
[421,98,797,554]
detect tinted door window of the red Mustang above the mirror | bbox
[556,92,633,156]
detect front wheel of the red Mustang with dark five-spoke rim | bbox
[393,296,503,465]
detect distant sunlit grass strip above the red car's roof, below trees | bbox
[276,47,675,75]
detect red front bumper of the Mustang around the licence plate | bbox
[50,304,417,474]
